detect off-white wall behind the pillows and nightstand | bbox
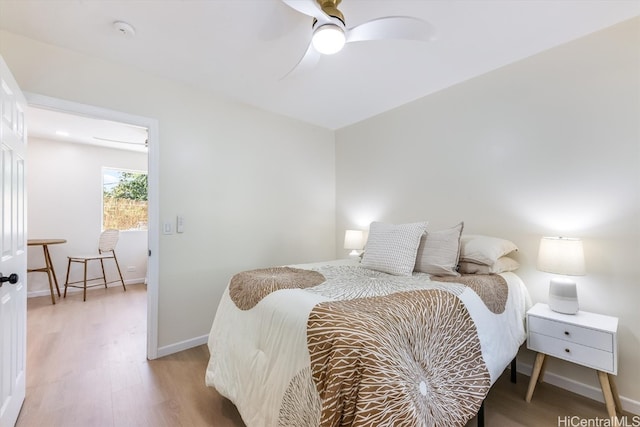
[336,19,640,411]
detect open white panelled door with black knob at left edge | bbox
[0,56,27,427]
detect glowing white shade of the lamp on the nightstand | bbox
[538,237,585,276]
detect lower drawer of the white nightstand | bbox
[528,331,613,372]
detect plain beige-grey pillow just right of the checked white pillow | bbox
[415,222,464,276]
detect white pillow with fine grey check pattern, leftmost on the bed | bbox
[360,221,427,276]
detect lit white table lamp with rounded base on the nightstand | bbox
[538,237,585,314]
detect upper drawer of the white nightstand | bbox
[528,316,613,353]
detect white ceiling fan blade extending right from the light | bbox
[346,16,435,43]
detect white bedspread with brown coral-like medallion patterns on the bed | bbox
[206,265,528,427]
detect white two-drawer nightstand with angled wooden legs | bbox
[525,303,622,417]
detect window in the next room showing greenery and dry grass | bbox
[102,168,148,230]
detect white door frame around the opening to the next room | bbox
[24,92,160,360]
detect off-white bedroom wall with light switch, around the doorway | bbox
[0,32,335,353]
